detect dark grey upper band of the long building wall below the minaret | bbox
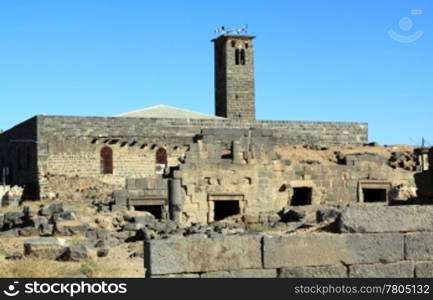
[37,116,368,145]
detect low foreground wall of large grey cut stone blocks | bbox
[144,206,433,278]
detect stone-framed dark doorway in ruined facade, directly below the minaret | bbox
[208,194,246,223]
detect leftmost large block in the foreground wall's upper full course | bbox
[144,235,262,276]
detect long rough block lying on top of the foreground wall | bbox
[337,205,433,233]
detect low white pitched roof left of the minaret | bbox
[115,105,224,119]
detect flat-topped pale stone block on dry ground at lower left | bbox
[24,238,67,259]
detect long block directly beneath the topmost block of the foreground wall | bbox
[263,234,404,269]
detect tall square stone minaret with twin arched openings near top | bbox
[212,35,256,121]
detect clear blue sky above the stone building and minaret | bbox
[0,0,433,144]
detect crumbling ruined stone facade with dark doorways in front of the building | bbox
[174,129,415,224]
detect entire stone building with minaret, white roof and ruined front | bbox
[0,35,417,223]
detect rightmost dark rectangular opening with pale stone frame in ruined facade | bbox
[358,180,392,204]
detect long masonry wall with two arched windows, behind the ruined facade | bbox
[37,116,367,197]
